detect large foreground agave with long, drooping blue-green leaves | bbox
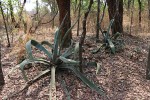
[5,19,105,100]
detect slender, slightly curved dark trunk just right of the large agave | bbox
[79,0,93,72]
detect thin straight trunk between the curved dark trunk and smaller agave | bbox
[96,0,100,42]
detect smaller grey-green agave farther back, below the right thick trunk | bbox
[93,19,124,54]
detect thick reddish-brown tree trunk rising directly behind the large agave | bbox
[56,0,72,47]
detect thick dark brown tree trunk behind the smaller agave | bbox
[106,0,123,34]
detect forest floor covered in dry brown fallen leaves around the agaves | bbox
[0,27,150,100]
